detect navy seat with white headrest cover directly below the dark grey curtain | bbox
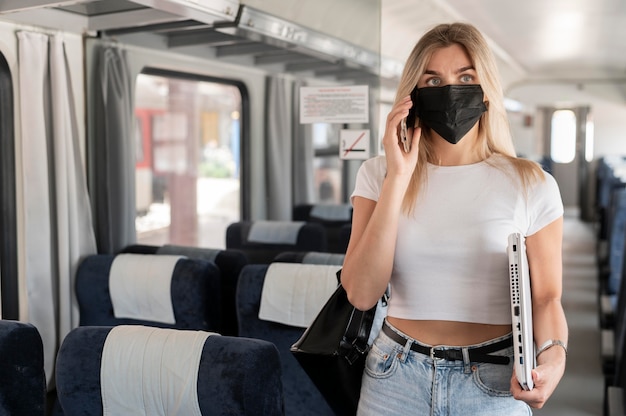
[76,254,222,332]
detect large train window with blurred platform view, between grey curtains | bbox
[135,73,242,248]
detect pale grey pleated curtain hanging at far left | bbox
[17,31,96,386]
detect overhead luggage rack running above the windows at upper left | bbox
[0,0,401,83]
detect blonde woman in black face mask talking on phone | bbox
[342,23,567,416]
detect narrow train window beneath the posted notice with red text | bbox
[312,123,343,204]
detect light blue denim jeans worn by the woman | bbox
[357,324,532,416]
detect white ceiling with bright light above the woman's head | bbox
[382,0,626,90]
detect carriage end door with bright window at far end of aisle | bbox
[539,107,593,219]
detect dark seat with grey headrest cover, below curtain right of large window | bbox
[226,221,328,264]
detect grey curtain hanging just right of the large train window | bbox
[265,77,294,221]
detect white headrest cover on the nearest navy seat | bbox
[100,325,213,416]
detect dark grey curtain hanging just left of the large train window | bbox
[89,45,136,254]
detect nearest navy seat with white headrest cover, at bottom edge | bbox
[56,325,283,416]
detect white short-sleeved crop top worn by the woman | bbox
[352,156,563,325]
